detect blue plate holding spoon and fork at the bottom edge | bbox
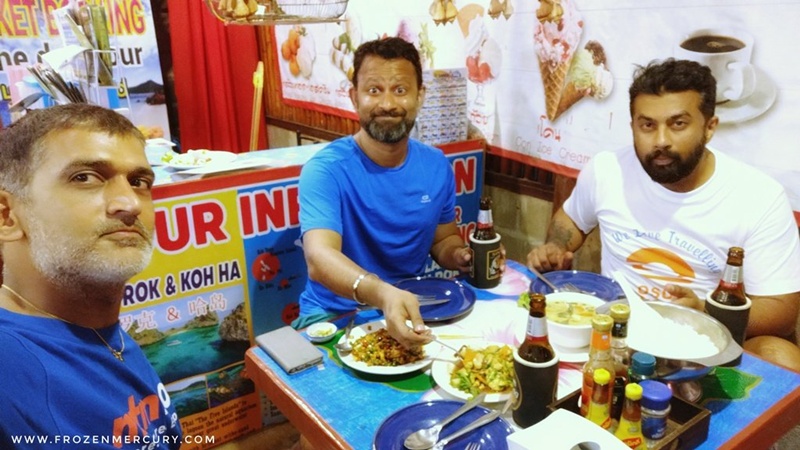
[372,400,514,450]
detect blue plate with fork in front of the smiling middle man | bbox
[394,277,475,322]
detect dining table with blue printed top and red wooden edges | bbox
[245,264,800,450]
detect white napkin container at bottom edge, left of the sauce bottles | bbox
[506,409,630,450]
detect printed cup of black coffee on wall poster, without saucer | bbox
[675,28,756,103]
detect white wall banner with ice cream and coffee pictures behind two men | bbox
[274,0,800,221]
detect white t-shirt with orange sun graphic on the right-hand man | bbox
[564,147,800,300]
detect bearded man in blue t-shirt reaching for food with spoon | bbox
[300,38,471,347]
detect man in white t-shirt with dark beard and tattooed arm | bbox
[528,59,800,370]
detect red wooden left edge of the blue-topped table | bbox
[244,347,352,450]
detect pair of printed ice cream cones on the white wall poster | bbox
[533,0,613,122]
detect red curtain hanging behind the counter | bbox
[168,0,267,153]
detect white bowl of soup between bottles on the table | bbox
[546,292,605,348]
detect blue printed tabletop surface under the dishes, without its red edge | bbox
[254,262,800,450]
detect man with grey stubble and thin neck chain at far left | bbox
[0,104,182,450]
